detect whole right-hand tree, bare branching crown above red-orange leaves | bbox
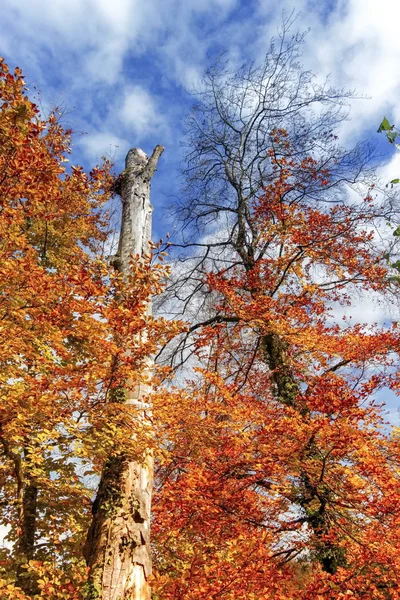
[155,21,400,600]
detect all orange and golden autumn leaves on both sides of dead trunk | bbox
[0,57,400,600]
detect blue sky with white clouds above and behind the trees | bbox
[0,0,400,422]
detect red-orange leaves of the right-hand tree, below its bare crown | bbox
[153,131,400,600]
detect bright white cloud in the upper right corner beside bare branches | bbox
[260,0,400,142]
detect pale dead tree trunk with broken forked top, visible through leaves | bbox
[84,146,164,600]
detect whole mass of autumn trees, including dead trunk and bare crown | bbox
[0,21,400,600]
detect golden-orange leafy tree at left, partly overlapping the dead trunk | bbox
[0,61,176,599]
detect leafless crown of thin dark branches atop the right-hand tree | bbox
[157,17,396,363]
